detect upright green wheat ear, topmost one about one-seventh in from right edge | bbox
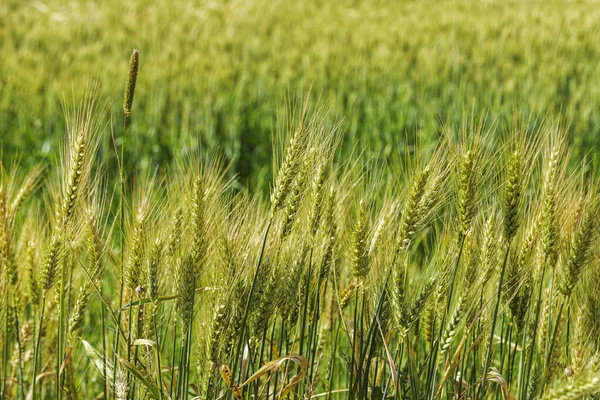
[503,151,523,243]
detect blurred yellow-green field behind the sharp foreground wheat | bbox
[0,0,600,188]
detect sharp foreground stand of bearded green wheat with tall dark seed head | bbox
[0,51,600,400]
